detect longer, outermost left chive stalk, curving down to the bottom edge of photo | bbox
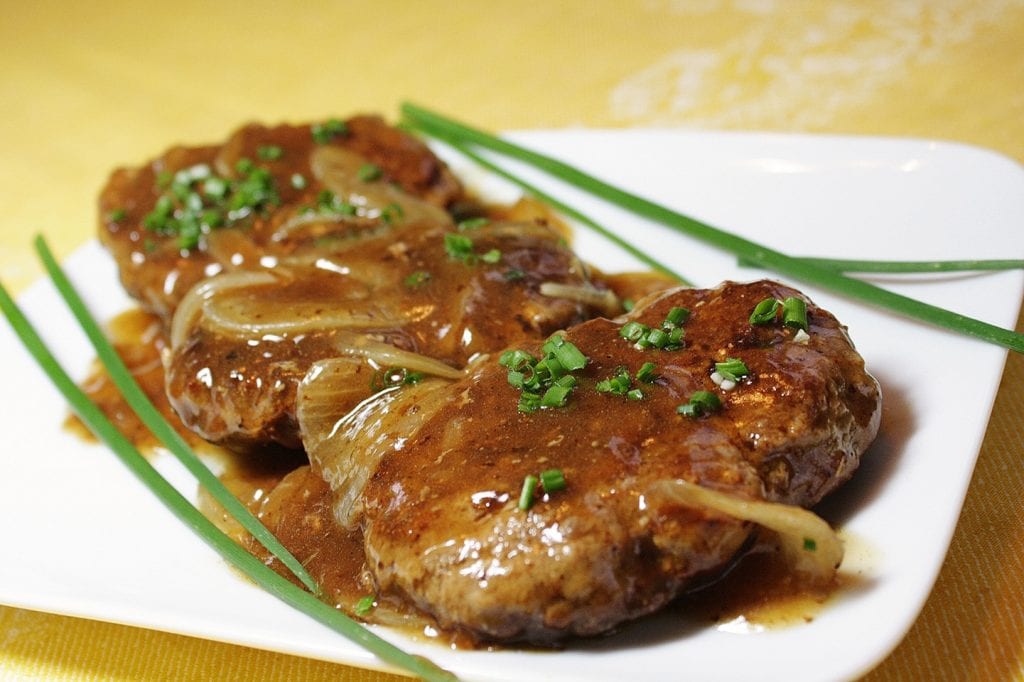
[0,284,455,682]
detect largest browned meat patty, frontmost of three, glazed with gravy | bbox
[300,282,881,642]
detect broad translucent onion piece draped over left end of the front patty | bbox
[296,357,447,528]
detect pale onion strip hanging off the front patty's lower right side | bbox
[647,479,843,582]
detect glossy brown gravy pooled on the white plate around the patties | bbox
[67,299,863,648]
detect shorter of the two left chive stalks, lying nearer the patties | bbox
[34,236,317,594]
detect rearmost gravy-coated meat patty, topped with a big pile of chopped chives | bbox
[99,116,463,322]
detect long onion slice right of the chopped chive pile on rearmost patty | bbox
[309,145,452,224]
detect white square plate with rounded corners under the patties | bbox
[0,130,1024,680]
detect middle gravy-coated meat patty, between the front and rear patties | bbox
[165,223,594,451]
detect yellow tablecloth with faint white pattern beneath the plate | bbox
[0,0,1024,680]
